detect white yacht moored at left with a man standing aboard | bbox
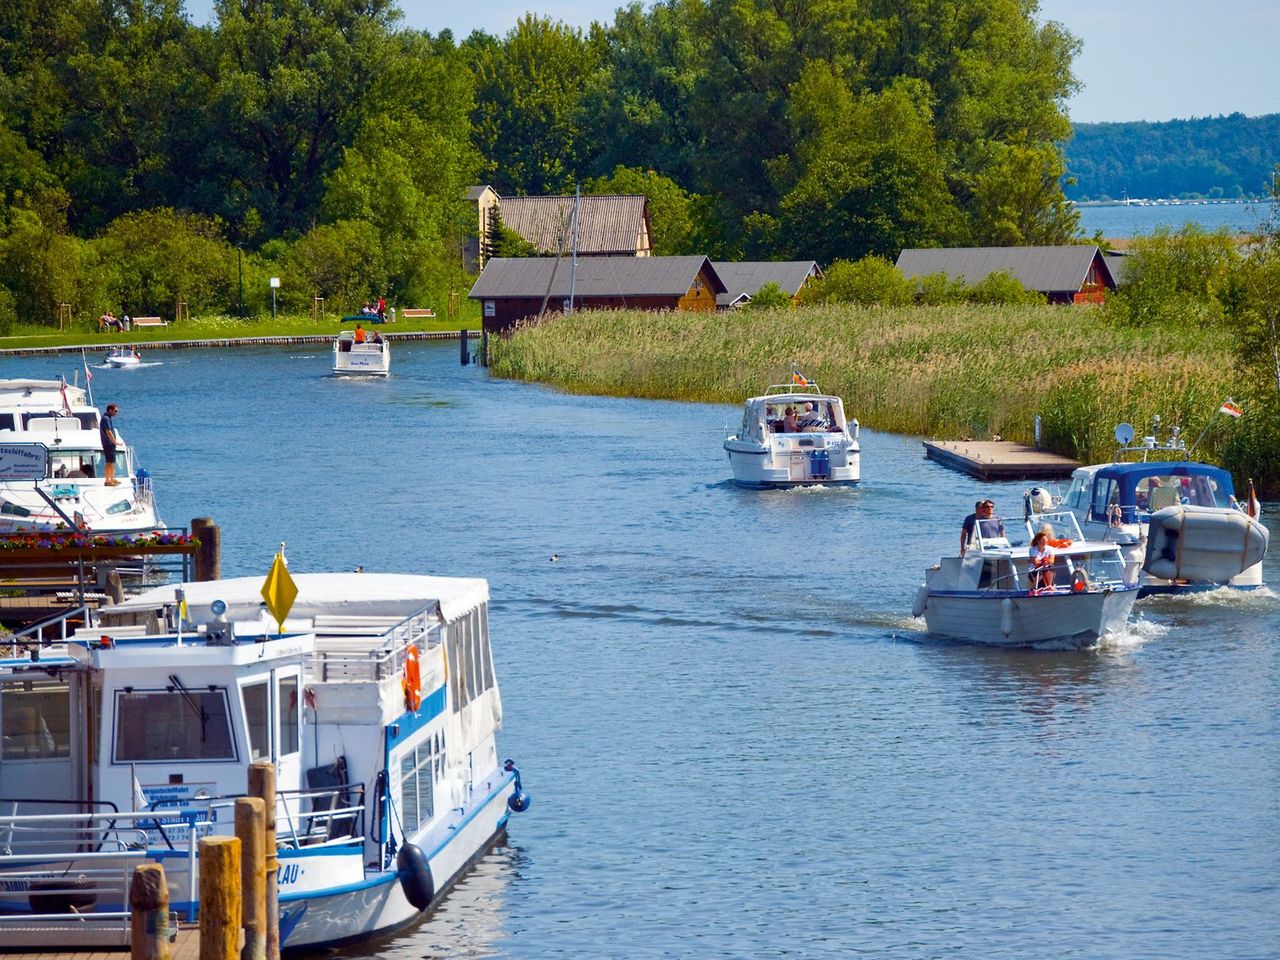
[0,380,164,534]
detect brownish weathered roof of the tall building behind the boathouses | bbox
[498,195,648,256]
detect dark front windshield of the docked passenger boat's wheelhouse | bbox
[113,687,236,763]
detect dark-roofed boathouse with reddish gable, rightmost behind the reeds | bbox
[897,244,1116,303]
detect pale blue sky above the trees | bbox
[187,0,1280,123]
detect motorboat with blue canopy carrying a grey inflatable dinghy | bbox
[1036,417,1270,596]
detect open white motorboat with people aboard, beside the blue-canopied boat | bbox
[913,511,1138,648]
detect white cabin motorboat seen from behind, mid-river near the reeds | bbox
[724,372,860,489]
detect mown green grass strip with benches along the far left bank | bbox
[0,310,480,349]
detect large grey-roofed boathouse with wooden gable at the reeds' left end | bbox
[468,256,727,333]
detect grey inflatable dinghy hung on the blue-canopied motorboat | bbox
[1142,506,1271,584]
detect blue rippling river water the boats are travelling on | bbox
[0,344,1280,960]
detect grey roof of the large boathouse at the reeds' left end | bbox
[468,256,724,300]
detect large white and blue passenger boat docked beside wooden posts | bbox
[0,573,530,950]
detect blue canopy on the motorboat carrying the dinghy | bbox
[1089,461,1235,518]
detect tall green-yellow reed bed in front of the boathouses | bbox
[492,306,1240,471]
